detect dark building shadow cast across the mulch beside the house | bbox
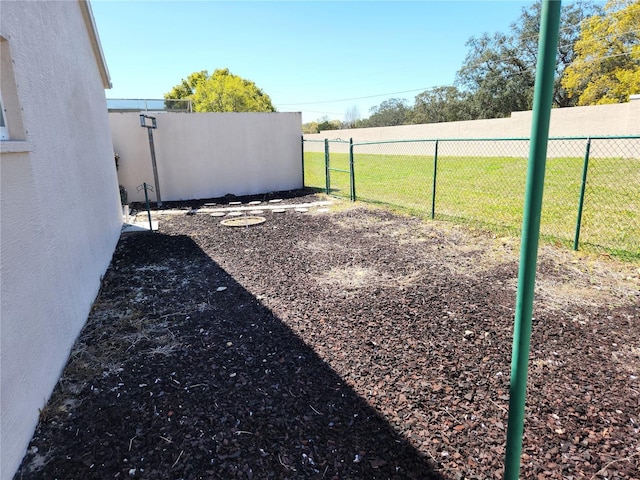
[15,233,443,479]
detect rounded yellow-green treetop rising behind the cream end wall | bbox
[164,68,276,112]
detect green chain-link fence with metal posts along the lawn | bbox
[303,136,640,259]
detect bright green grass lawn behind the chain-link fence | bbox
[304,152,640,259]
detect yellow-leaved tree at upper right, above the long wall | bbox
[562,0,640,105]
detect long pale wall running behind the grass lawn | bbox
[304,95,640,158]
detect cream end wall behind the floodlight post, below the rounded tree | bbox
[109,112,303,202]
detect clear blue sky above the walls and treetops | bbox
[91,0,532,122]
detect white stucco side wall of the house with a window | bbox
[0,1,122,480]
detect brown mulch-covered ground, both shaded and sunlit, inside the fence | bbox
[16,196,640,480]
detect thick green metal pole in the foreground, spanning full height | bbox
[504,0,560,480]
